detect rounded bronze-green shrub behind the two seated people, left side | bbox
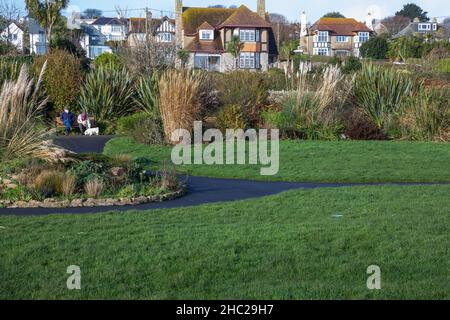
[34,50,83,110]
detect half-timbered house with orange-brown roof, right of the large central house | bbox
[300,18,374,57]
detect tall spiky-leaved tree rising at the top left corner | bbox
[25,0,69,49]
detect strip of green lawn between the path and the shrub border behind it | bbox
[105,138,450,182]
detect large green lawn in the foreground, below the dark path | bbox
[0,186,450,299]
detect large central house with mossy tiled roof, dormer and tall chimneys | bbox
[176,0,278,72]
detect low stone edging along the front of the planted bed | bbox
[0,186,187,209]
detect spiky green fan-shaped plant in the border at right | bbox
[354,64,416,129]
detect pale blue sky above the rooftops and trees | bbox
[10,0,450,22]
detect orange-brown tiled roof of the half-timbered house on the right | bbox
[310,18,373,36]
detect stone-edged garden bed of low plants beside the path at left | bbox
[0,155,185,208]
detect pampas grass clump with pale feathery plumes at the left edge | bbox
[0,63,67,161]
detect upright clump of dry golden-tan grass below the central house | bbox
[159,70,204,141]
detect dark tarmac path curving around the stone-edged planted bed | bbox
[0,136,444,215]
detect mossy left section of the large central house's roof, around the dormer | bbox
[182,7,237,35]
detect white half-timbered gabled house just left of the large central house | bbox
[128,16,175,47]
